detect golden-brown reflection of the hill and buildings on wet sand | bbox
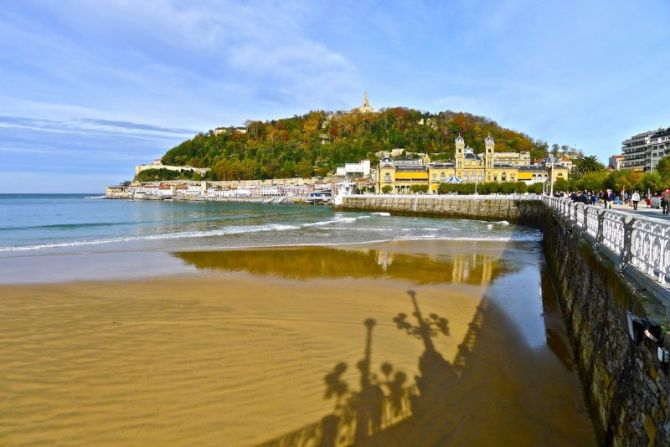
[173,247,511,285]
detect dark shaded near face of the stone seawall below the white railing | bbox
[543,210,670,446]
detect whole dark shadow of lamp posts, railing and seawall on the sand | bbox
[253,242,593,447]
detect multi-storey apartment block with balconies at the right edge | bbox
[621,127,670,172]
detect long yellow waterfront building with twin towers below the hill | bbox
[376,135,569,194]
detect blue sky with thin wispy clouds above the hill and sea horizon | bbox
[0,0,670,193]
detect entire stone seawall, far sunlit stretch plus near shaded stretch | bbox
[339,195,670,446]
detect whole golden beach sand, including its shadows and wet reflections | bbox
[0,242,595,446]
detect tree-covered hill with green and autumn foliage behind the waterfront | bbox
[151,107,548,180]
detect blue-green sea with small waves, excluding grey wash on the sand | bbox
[0,194,541,257]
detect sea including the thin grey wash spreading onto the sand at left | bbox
[0,194,541,284]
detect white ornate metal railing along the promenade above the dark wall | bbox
[542,196,670,288]
